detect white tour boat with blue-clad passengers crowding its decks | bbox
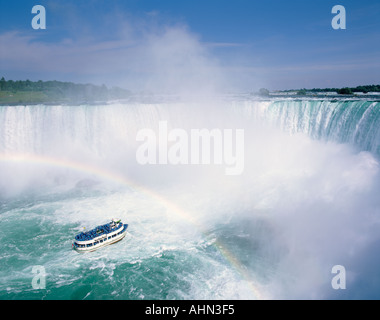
[72,219,128,252]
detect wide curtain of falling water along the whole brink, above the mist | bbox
[0,100,380,156]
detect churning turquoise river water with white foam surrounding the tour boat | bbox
[0,190,264,299]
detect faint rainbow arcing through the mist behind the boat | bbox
[0,153,267,300]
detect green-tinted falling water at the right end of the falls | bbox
[235,100,380,156]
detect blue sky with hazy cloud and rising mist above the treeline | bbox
[0,0,380,92]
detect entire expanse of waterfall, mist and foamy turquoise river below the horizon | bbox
[0,99,380,299]
